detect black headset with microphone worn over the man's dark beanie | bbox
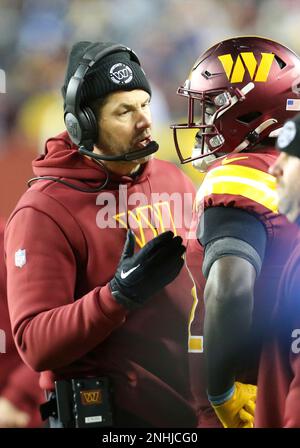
[64,44,158,161]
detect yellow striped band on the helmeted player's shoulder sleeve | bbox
[197,165,278,213]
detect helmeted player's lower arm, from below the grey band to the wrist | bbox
[204,255,256,395]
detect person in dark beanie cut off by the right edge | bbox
[255,115,300,428]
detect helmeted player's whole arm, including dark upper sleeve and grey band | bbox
[198,207,266,428]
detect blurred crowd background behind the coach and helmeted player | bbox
[0,0,300,217]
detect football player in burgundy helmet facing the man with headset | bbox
[172,36,300,427]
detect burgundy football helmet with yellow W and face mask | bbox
[171,36,300,171]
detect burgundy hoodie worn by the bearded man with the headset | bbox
[6,133,206,427]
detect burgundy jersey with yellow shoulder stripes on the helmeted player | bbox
[186,148,297,425]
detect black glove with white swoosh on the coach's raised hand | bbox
[110,230,185,309]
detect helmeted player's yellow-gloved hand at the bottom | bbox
[210,382,257,428]
